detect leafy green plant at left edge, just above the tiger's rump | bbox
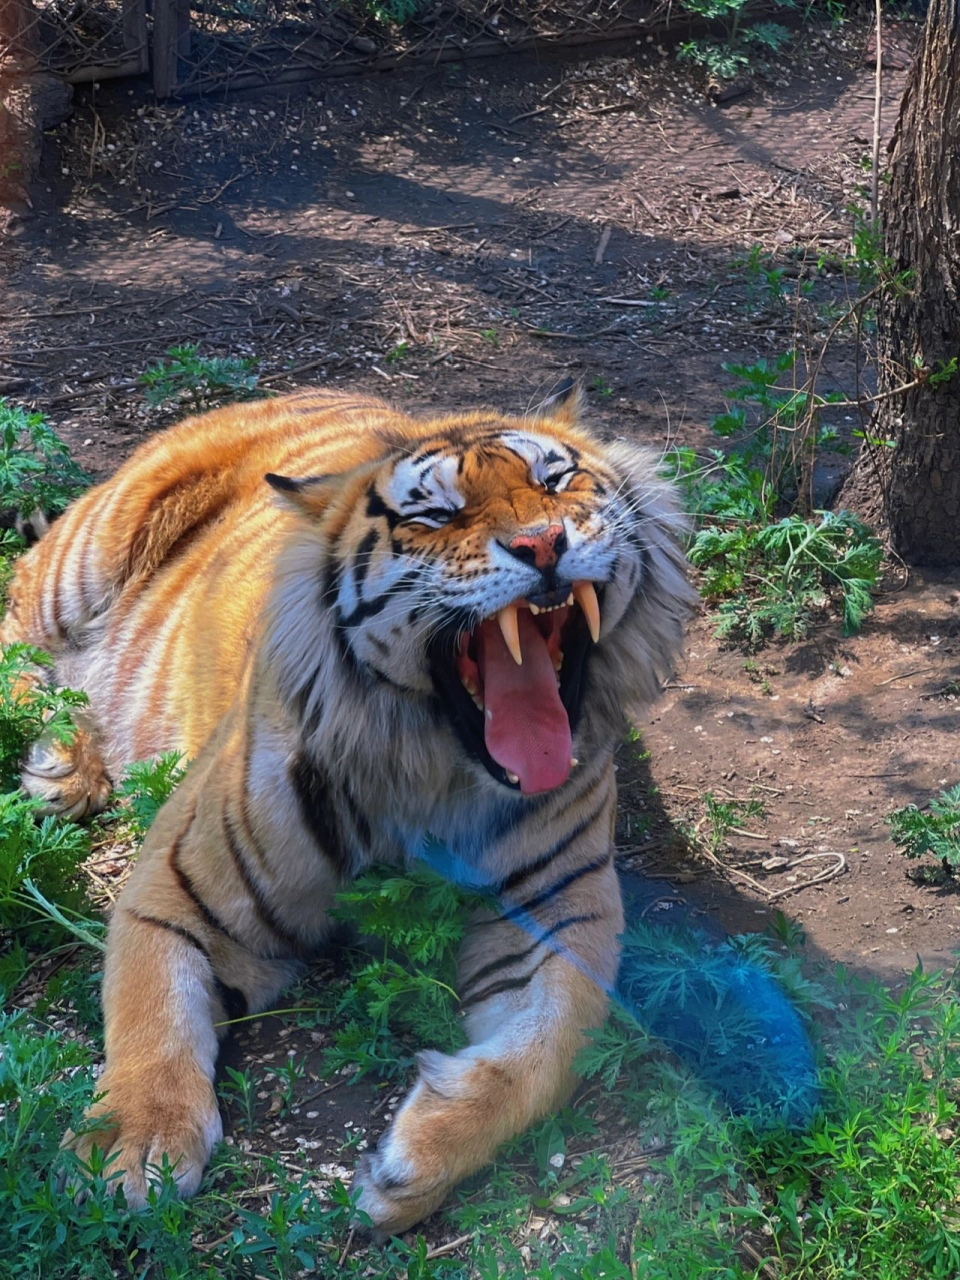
[0,397,90,516]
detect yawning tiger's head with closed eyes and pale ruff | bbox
[268,384,689,795]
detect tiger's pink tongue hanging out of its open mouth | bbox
[477,609,572,795]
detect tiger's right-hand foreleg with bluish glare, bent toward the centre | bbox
[356,788,622,1233]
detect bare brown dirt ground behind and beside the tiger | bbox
[0,5,960,1249]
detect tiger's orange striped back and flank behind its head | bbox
[0,389,416,771]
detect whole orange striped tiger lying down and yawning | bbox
[0,387,690,1236]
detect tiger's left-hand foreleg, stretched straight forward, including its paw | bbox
[64,741,317,1208]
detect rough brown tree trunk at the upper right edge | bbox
[855,0,960,564]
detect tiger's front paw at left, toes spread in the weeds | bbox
[60,1071,223,1210]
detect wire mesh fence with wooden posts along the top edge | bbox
[0,0,673,99]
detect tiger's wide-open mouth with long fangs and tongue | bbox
[431,582,600,795]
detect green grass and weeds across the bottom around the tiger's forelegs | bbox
[0,834,960,1280]
